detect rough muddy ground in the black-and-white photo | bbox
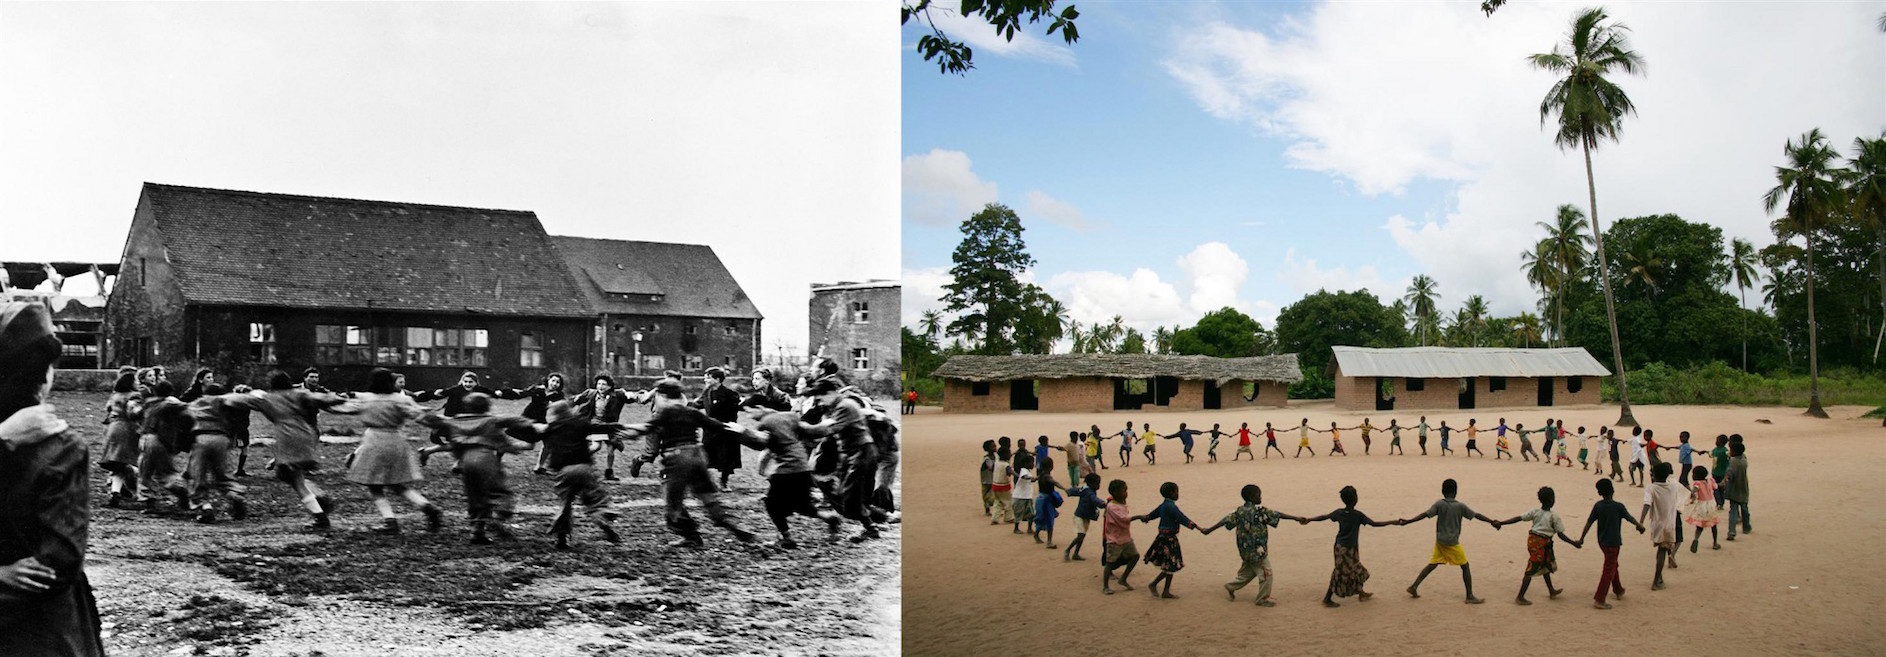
[51,393,902,657]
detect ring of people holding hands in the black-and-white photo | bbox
[100,361,898,549]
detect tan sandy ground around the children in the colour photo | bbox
[903,402,1886,655]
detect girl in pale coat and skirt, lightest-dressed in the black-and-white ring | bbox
[347,368,445,534]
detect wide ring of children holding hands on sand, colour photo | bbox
[981,415,1752,610]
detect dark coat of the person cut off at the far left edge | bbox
[0,428,106,657]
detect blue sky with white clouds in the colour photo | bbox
[902,0,1886,336]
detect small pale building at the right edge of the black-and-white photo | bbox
[807,281,903,395]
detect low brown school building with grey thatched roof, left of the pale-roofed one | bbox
[935,353,1303,413]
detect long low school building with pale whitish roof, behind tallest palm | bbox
[1332,347,1611,412]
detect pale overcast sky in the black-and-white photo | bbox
[0,2,900,351]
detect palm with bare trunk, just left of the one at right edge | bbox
[1762,128,1841,417]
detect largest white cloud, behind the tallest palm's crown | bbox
[1166,2,1886,313]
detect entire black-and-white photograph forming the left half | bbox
[0,2,907,657]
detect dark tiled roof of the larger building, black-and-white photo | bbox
[143,183,594,317]
